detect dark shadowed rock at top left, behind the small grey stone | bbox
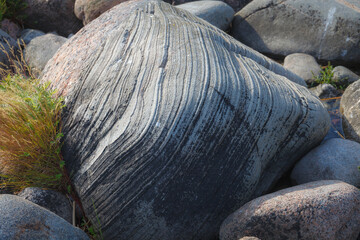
[22,0,83,36]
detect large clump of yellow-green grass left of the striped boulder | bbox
[0,74,66,191]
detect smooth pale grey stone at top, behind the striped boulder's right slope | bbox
[176,1,235,31]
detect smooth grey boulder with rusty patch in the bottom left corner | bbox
[0,194,89,240]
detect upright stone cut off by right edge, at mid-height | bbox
[340,80,360,143]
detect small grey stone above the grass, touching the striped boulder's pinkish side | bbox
[24,33,67,75]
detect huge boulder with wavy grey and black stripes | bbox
[42,0,329,239]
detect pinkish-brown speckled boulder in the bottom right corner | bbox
[220,181,360,240]
